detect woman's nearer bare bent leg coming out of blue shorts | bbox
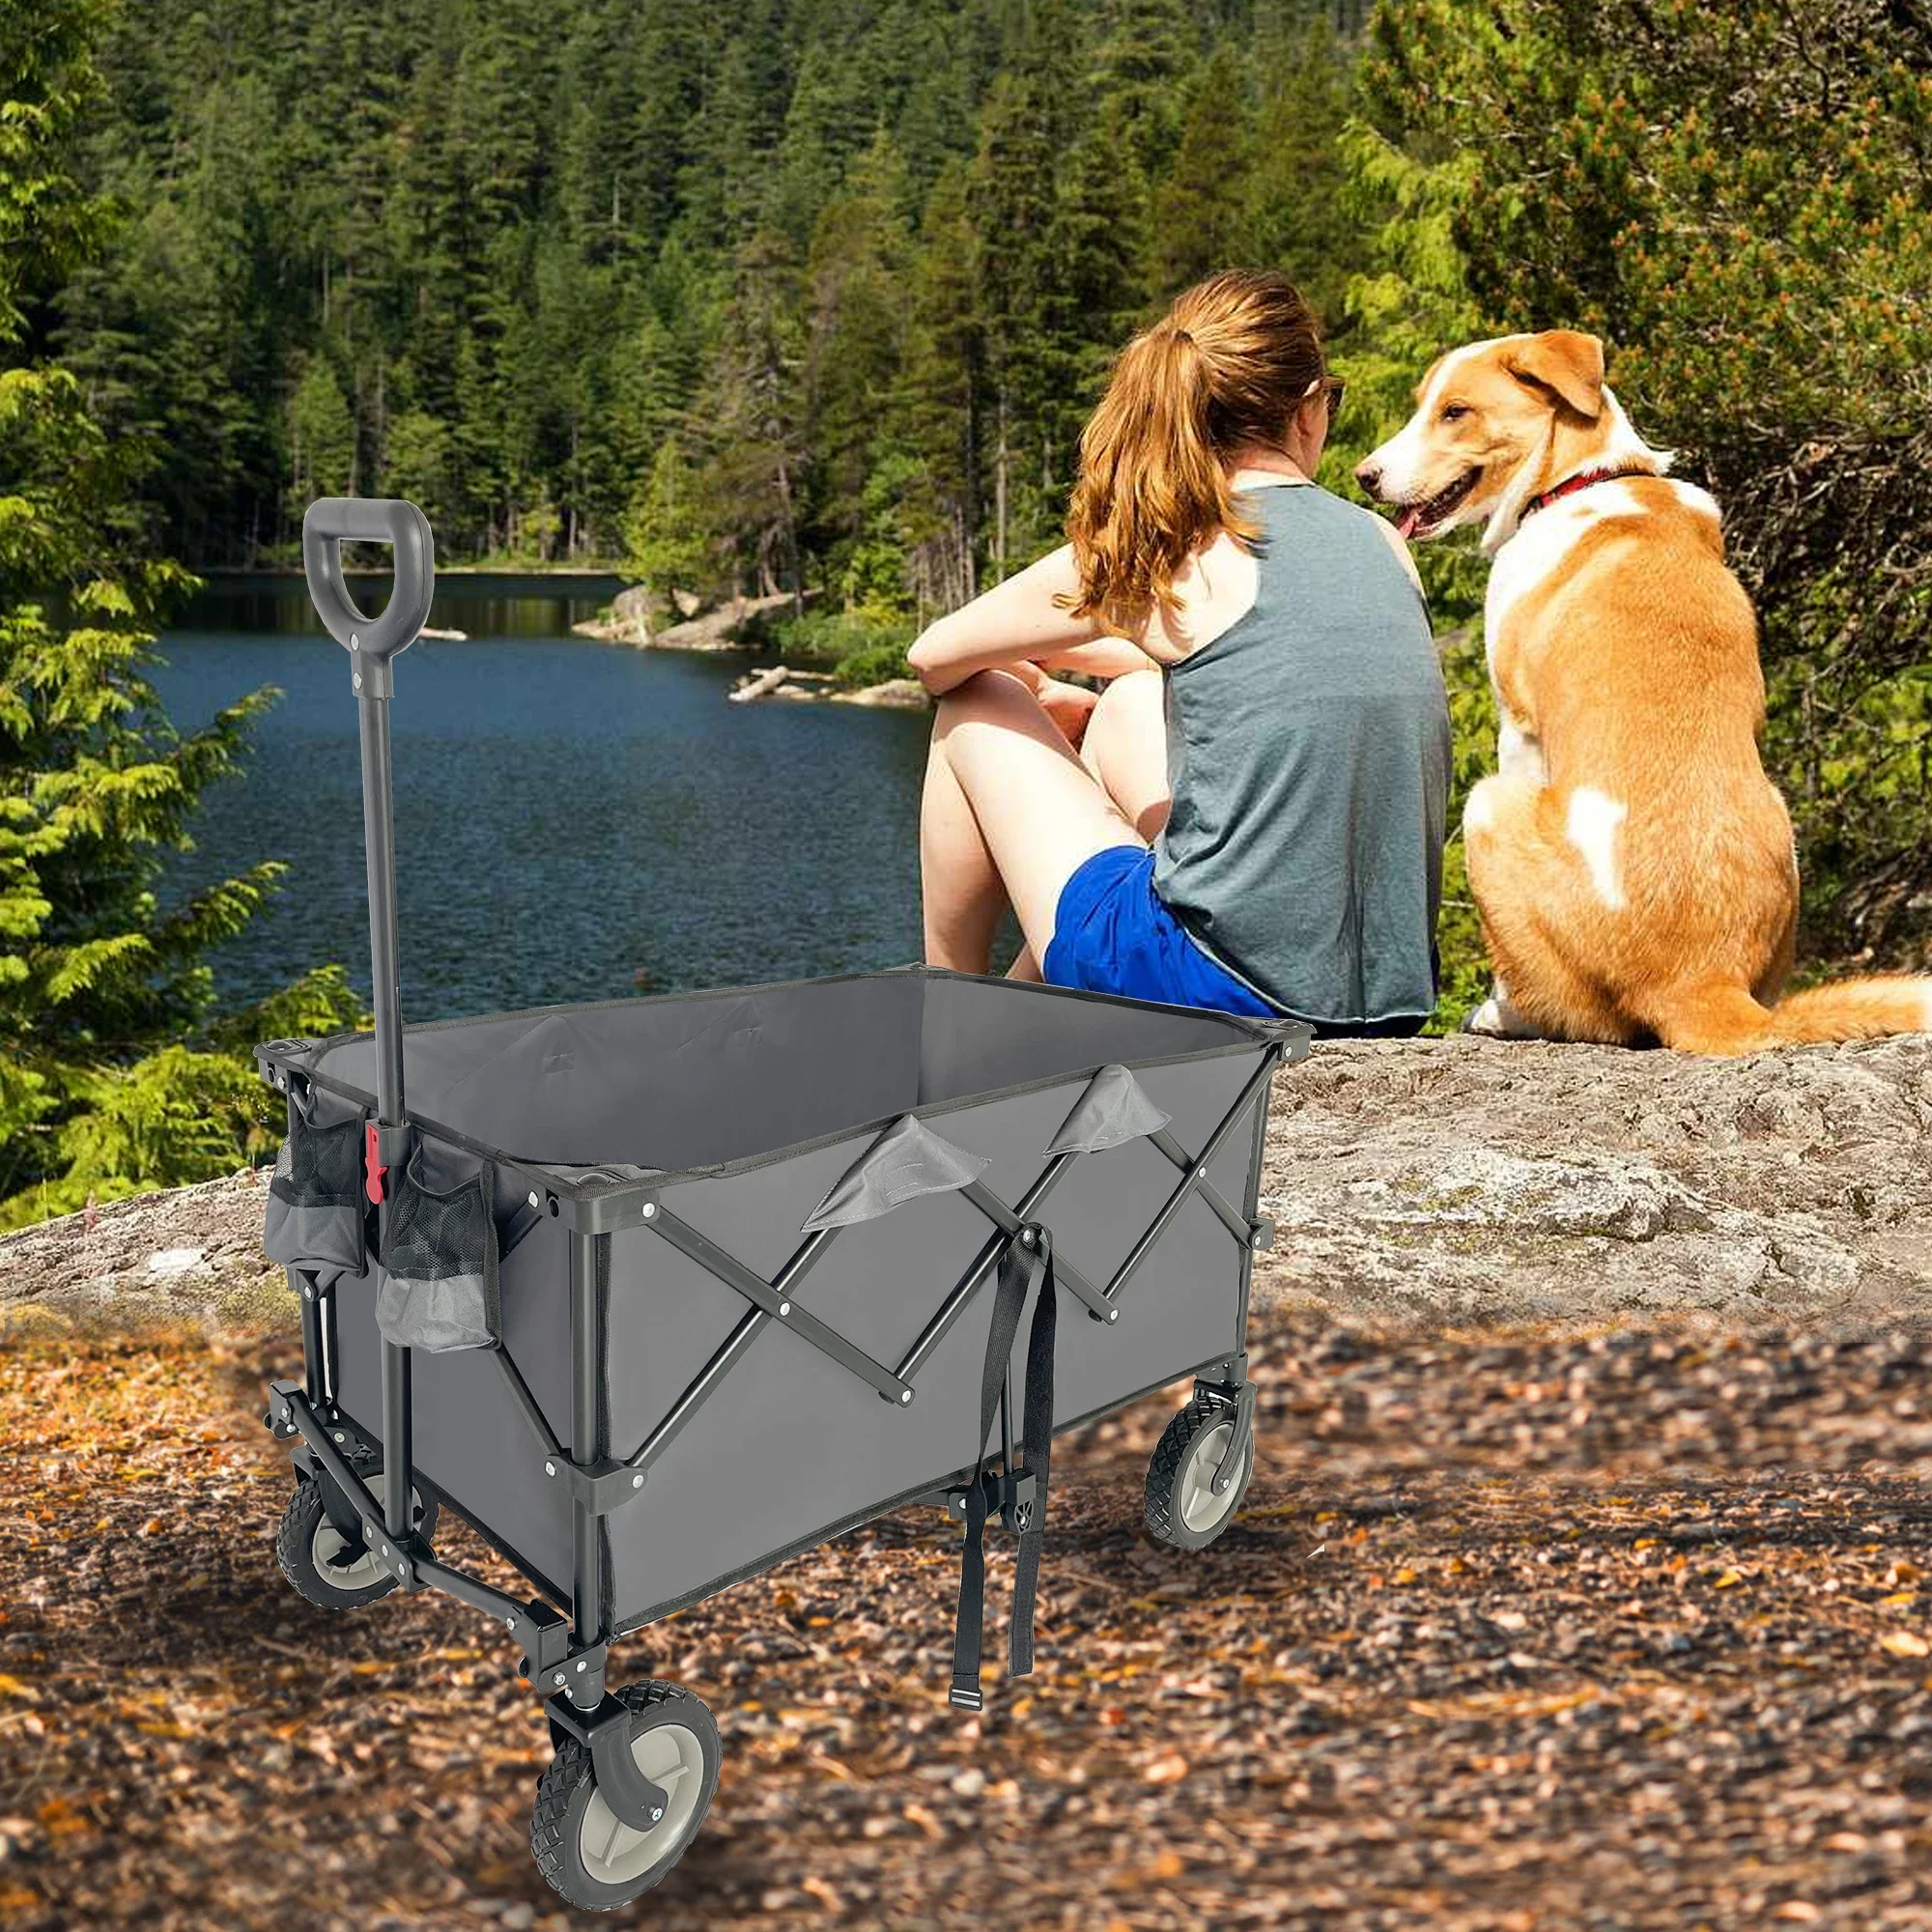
[920,670,1144,972]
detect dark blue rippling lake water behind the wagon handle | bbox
[155,576,927,1020]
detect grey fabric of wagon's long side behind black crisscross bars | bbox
[607,1049,1262,1627]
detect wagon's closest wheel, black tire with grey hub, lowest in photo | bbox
[529,1677,721,1913]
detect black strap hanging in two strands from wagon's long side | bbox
[949,1223,1059,1710]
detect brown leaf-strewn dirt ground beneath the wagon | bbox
[0,1298,1932,1932]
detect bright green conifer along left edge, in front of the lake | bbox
[0,0,354,1221]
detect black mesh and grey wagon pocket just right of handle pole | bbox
[375,1140,502,1354]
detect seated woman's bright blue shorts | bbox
[1039,846,1279,1020]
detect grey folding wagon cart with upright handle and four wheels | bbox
[257,498,1308,1907]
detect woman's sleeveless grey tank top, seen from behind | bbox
[1153,485,1449,1026]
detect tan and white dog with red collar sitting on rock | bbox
[1356,328,1932,1053]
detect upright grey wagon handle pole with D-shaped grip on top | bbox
[301,497,437,1540]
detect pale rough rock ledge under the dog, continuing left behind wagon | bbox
[0,1037,1932,1329]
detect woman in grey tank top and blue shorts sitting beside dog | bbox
[912,272,1449,1034]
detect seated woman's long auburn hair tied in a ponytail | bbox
[1066,270,1323,639]
